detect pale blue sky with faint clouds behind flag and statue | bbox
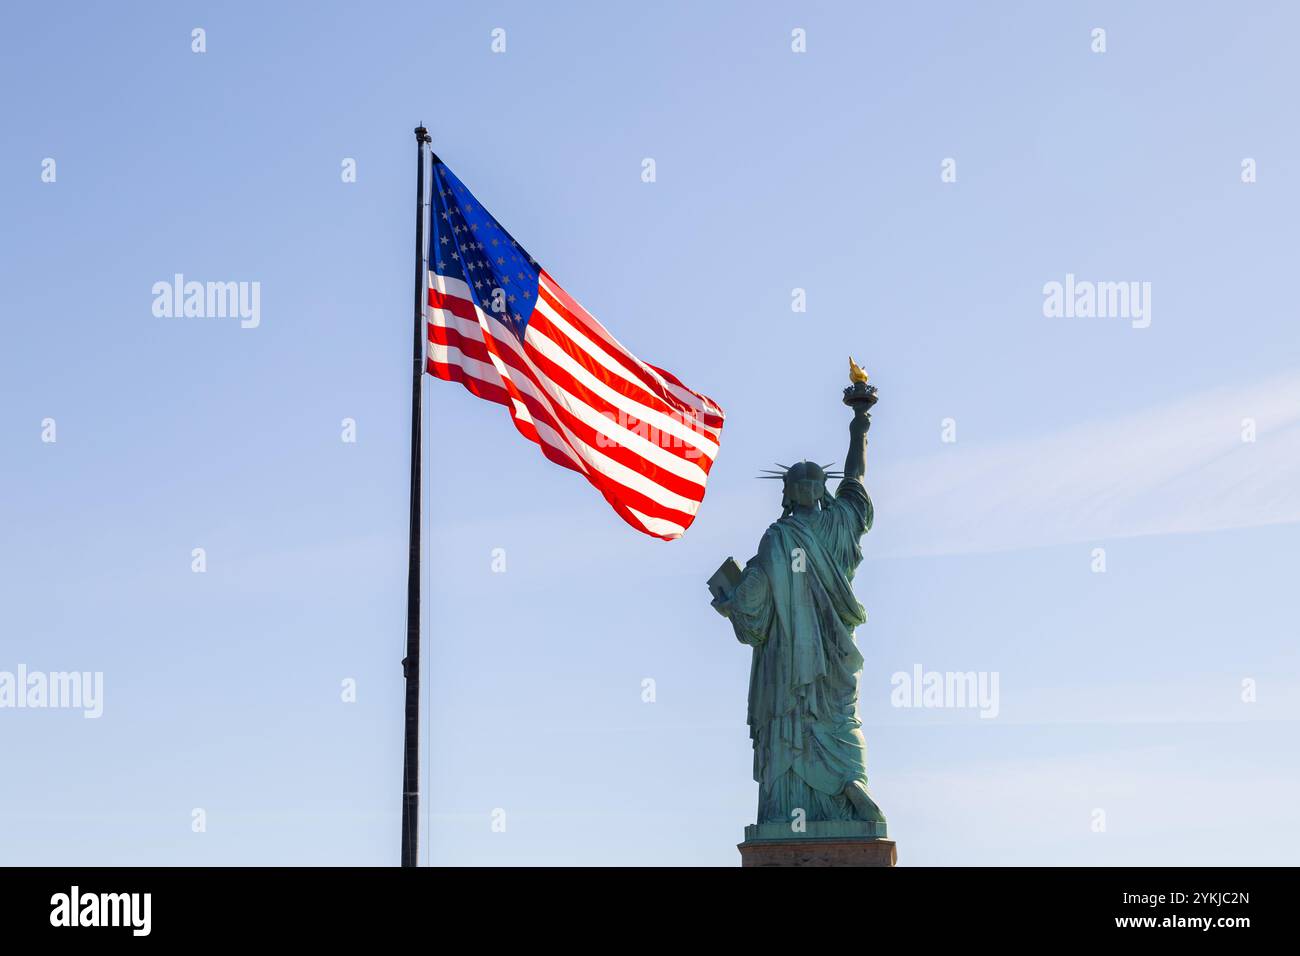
[0,3,1300,865]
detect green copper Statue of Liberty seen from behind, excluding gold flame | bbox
[711,381,887,840]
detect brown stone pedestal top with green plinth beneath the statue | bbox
[737,821,898,866]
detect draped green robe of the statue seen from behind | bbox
[731,477,872,823]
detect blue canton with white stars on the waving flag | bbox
[429,156,541,342]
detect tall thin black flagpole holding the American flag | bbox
[402,126,432,866]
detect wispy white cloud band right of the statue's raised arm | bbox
[871,372,1300,557]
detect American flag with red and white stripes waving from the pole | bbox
[426,156,723,540]
